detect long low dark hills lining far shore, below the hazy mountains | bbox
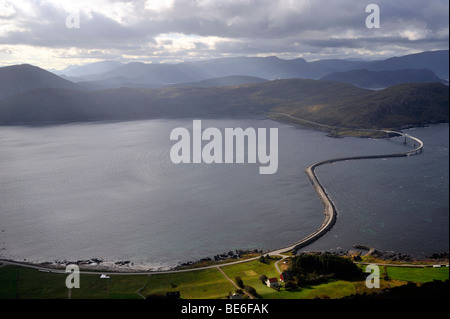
[0,79,449,128]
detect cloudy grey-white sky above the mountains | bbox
[0,0,449,69]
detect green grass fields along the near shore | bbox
[0,260,449,299]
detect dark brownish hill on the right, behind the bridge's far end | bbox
[275,83,449,129]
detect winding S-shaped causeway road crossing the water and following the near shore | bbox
[0,113,424,275]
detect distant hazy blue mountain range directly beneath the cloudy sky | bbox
[54,50,449,88]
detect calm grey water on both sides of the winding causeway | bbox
[0,119,449,268]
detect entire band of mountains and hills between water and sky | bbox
[0,51,449,128]
